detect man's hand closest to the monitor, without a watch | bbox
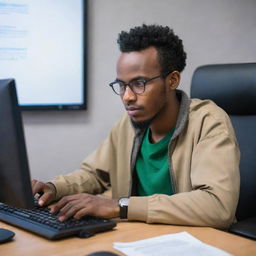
[31,179,56,206]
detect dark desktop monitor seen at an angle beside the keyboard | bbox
[0,80,34,208]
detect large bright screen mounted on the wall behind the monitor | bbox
[0,0,87,110]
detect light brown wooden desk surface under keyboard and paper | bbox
[0,222,256,256]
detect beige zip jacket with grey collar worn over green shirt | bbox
[51,91,240,229]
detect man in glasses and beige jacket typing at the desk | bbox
[32,25,240,228]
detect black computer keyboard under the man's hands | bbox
[0,203,116,240]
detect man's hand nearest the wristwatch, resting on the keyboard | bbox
[49,194,119,221]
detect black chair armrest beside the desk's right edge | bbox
[229,217,256,240]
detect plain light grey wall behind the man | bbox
[23,0,256,180]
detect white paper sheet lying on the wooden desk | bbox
[113,232,231,256]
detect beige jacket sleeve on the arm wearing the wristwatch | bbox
[128,109,240,229]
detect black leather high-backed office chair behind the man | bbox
[191,63,256,240]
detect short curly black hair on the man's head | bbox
[117,24,187,73]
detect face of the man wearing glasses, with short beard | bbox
[117,47,168,125]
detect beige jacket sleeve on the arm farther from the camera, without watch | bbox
[50,127,115,200]
